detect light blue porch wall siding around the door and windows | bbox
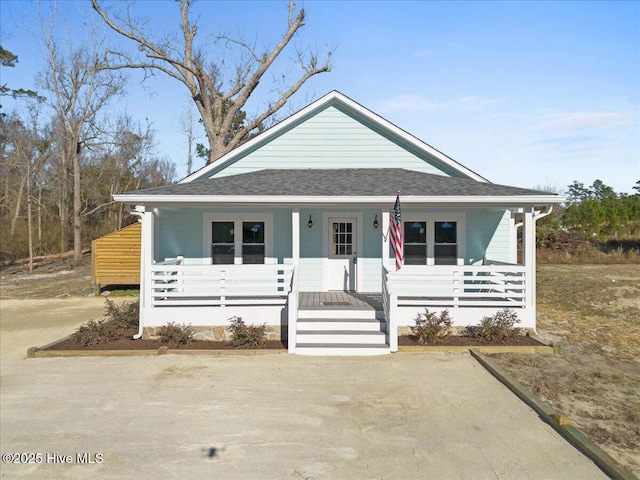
[155,204,515,292]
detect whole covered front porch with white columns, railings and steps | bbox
[124,175,556,354]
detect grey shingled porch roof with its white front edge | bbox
[114,168,563,204]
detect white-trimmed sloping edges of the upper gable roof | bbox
[179,90,488,183]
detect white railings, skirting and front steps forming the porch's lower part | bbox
[141,255,535,354]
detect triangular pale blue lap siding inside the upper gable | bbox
[210,107,460,176]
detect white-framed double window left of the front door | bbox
[204,213,273,265]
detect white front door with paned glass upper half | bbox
[327,217,358,291]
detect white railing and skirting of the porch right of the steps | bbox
[382,265,528,352]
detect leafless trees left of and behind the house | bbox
[0,0,333,265]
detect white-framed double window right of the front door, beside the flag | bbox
[403,217,465,265]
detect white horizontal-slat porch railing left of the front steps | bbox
[149,262,293,307]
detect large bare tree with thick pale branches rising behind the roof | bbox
[91,0,333,163]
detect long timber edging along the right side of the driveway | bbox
[469,348,639,480]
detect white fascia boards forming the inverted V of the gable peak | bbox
[178,90,490,183]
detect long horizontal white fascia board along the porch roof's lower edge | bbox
[113,195,566,206]
